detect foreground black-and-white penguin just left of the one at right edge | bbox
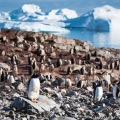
[93,81,103,101]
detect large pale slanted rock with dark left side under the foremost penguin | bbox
[11,95,59,112]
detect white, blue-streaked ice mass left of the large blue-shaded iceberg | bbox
[0,4,78,33]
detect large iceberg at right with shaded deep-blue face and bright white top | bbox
[66,5,120,30]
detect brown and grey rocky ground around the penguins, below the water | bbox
[0,30,120,120]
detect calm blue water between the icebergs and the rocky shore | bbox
[56,28,120,49]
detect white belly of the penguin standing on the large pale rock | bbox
[28,78,40,99]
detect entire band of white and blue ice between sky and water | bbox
[0,4,120,33]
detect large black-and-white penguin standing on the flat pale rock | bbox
[27,73,40,102]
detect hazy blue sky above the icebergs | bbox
[0,0,120,16]
